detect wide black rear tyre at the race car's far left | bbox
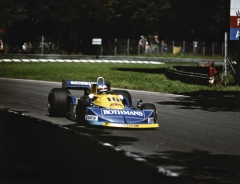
[47,88,70,116]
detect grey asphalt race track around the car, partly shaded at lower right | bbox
[0,79,240,183]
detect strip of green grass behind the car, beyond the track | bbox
[0,62,240,97]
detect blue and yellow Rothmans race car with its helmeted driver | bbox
[47,77,159,128]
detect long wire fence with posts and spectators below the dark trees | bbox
[4,38,229,56]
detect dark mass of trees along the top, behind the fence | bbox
[0,0,230,54]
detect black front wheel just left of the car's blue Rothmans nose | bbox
[76,100,90,126]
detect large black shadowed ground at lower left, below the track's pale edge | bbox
[0,110,176,184]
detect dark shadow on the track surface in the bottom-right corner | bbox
[146,150,240,184]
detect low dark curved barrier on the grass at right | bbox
[165,68,210,85]
